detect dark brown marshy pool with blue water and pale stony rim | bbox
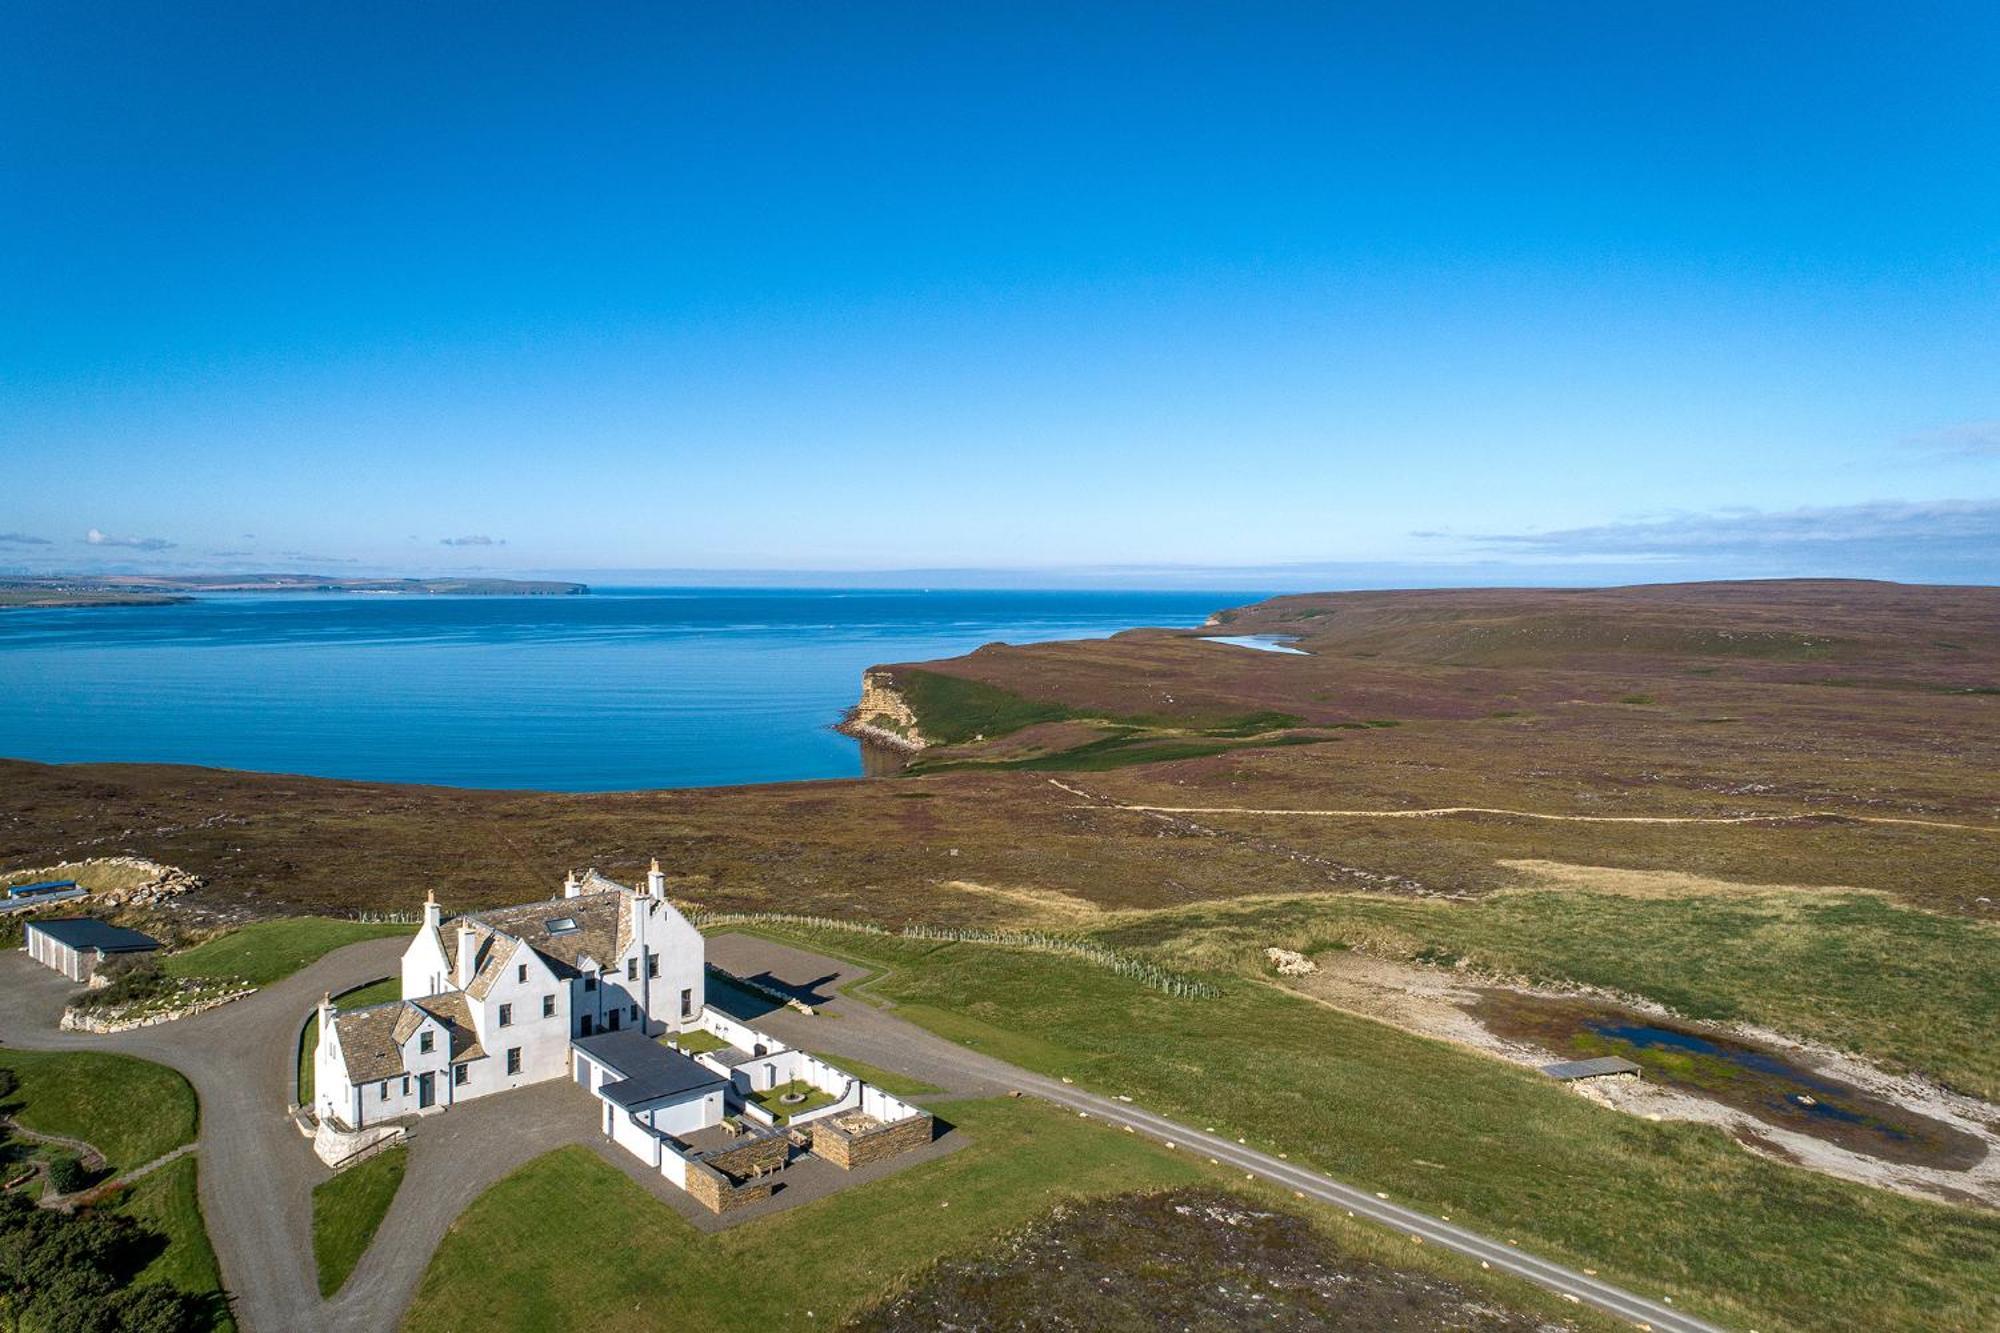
[1470,989,1986,1171]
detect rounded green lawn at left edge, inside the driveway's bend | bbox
[0,1049,200,1175]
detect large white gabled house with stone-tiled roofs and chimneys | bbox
[314,861,706,1129]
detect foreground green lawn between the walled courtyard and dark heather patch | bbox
[404,1099,1610,1333]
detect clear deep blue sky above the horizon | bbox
[0,0,2000,586]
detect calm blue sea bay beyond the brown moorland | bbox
[0,588,1258,791]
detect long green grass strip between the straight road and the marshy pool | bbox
[740,931,2000,1331]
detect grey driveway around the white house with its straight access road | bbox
[0,935,1716,1333]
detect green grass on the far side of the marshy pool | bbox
[1106,889,2000,1099]
